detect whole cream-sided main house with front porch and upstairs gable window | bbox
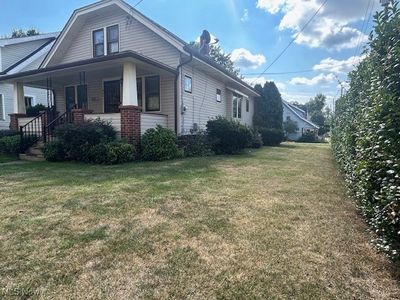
[0,0,259,145]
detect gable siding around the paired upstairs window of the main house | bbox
[49,9,179,67]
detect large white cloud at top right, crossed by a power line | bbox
[257,0,379,50]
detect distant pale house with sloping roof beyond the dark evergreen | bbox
[283,101,319,141]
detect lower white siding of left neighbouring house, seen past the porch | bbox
[0,83,47,130]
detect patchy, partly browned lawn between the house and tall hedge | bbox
[0,144,400,299]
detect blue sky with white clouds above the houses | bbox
[0,0,380,105]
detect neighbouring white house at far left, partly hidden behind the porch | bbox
[0,33,57,130]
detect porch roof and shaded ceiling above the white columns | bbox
[0,51,177,88]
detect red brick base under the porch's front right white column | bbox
[119,105,142,147]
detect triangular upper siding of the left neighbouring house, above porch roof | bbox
[1,39,48,70]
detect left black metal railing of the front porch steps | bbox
[19,107,57,153]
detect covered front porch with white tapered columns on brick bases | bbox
[2,51,177,148]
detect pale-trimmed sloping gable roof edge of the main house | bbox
[39,0,259,96]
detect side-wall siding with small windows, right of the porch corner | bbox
[181,65,228,133]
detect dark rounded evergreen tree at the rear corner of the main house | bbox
[253,82,283,131]
